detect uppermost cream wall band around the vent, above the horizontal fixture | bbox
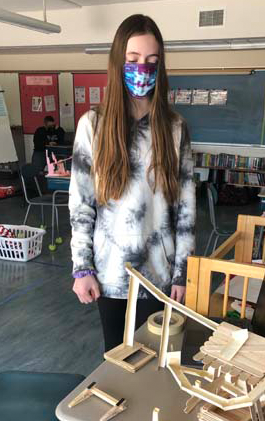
[0,0,265,46]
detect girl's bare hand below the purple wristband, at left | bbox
[73,275,100,304]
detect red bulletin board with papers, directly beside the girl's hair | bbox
[73,73,107,127]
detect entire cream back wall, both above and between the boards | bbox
[0,0,265,158]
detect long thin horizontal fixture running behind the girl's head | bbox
[85,37,265,54]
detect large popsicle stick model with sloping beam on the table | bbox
[105,262,265,421]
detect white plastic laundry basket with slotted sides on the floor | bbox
[0,224,46,262]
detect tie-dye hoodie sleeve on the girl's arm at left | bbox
[69,114,96,277]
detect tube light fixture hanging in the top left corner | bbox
[0,8,61,34]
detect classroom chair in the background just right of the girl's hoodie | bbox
[204,183,232,256]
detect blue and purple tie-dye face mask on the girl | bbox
[123,63,157,98]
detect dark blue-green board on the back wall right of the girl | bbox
[169,71,265,145]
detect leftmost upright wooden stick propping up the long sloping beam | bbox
[123,275,139,346]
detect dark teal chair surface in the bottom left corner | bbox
[0,371,85,421]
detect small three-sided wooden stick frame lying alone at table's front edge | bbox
[68,382,127,421]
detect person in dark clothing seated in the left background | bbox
[32,116,65,171]
